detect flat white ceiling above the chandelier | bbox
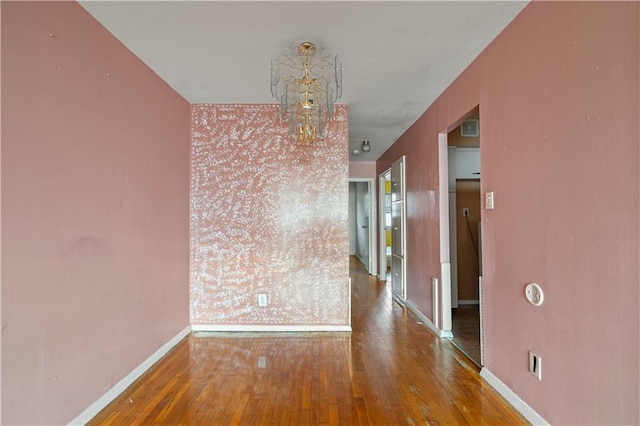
[80,1,527,161]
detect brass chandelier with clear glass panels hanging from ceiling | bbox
[271,41,342,144]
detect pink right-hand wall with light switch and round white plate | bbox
[377,2,640,424]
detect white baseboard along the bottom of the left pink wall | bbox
[69,325,191,425]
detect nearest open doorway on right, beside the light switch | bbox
[440,108,483,366]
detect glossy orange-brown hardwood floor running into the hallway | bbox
[90,259,527,425]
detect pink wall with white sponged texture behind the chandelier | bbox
[191,105,350,326]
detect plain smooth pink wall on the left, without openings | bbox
[2,2,189,424]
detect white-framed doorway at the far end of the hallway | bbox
[349,179,378,275]
